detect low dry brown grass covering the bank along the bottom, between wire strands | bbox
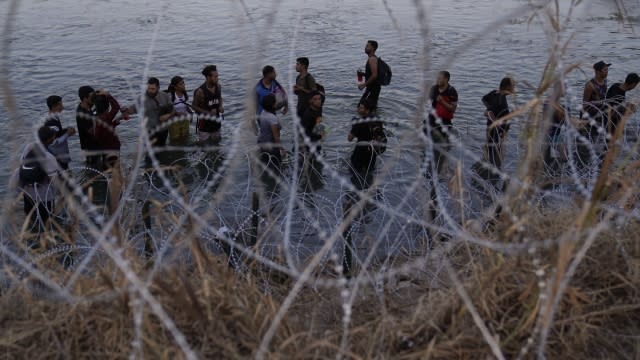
[0,207,640,359]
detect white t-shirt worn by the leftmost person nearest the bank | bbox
[9,144,58,203]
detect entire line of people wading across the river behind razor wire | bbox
[7,40,640,248]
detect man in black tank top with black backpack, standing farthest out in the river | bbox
[358,40,391,112]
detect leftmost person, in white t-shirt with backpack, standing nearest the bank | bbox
[10,126,58,239]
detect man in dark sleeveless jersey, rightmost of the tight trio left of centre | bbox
[191,65,224,142]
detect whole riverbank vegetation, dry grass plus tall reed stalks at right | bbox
[0,1,640,359]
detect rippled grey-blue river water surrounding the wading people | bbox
[0,0,640,258]
